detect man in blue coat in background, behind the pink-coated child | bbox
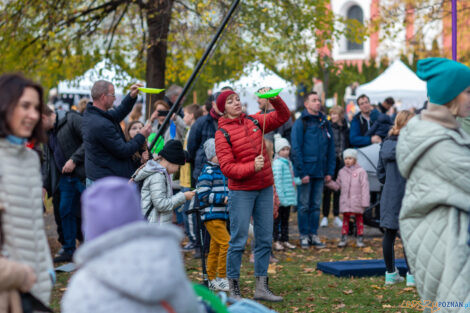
[349,95,382,148]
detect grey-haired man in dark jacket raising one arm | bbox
[82,80,151,187]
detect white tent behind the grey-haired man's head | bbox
[57,60,137,96]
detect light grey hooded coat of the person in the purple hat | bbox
[62,222,201,313]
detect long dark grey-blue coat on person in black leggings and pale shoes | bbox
[377,136,406,229]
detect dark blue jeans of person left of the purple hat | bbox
[59,176,85,254]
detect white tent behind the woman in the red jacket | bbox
[214,62,296,114]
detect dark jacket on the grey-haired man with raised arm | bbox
[82,95,145,181]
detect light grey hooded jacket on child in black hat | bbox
[133,160,186,224]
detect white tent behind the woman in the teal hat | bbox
[356,60,427,110]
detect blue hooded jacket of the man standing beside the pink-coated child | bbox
[291,110,336,178]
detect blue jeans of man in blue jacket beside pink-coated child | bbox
[297,178,324,238]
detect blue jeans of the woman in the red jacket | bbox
[227,186,273,279]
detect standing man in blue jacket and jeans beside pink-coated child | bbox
[291,92,336,249]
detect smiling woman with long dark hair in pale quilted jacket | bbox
[0,74,54,304]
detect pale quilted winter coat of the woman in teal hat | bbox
[397,104,470,312]
